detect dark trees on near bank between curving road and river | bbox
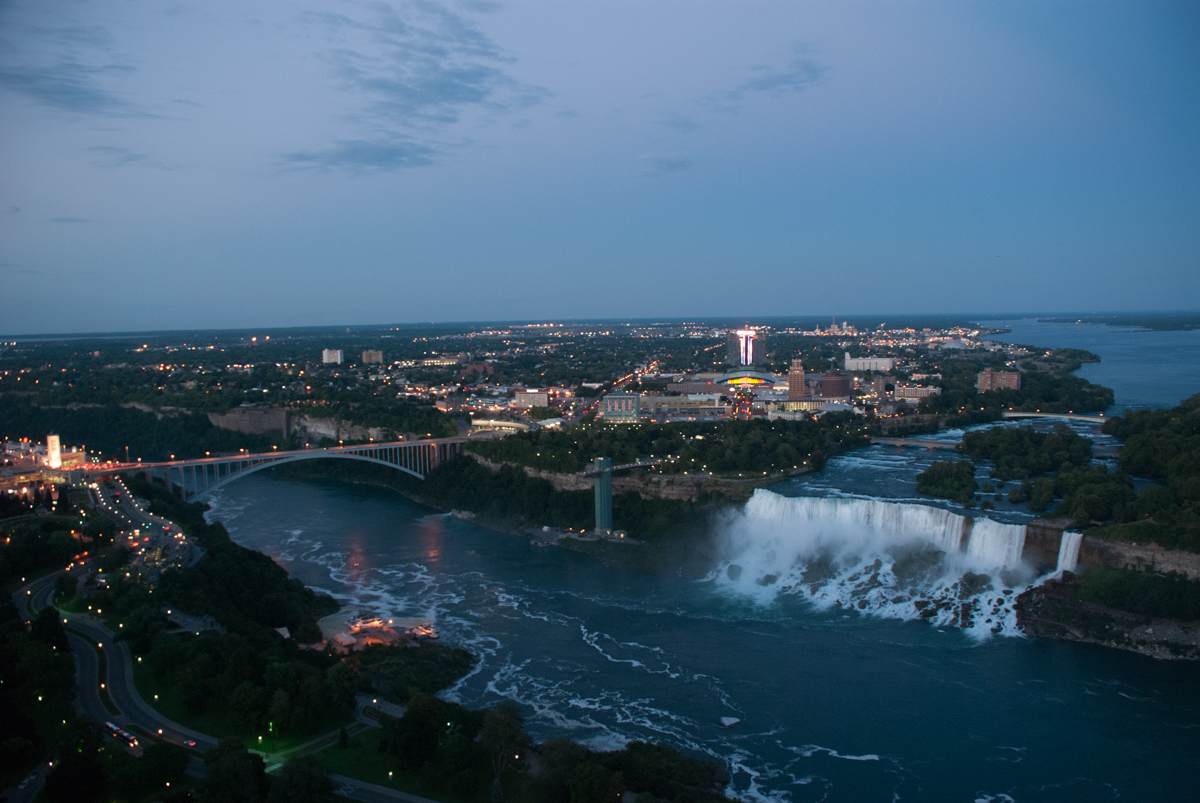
[94,478,474,737]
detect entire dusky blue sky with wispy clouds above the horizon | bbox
[0,0,1200,334]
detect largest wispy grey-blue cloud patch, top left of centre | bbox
[292,0,550,169]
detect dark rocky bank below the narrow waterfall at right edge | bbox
[1016,573,1200,660]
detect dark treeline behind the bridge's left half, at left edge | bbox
[0,394,289,462]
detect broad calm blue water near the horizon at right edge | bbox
[979,318,1200,415]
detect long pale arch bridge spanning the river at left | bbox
[85,437,466,501]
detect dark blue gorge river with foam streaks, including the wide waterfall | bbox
[210,321,1200,803]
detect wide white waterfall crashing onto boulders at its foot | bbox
[712,489,1032,637]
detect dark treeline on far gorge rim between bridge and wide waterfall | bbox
[467,413,868,475]
